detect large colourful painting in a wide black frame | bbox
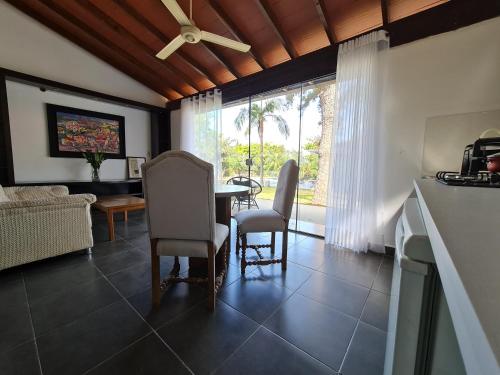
[46,104,126,159]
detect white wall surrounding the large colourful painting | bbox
[7,81,151,183]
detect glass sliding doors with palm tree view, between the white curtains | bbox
[221,77,335,236]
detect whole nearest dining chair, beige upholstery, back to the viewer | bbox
[142,151,229,310]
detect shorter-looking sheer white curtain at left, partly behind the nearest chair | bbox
[180,90,222,181]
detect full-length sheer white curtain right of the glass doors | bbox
[325,31,389,251]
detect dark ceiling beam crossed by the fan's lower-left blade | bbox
[113,0,222,85]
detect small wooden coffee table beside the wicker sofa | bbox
[94,194,144,241]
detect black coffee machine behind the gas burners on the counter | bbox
[460,137,500,176]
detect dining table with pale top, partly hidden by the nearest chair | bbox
[189,184,250,274]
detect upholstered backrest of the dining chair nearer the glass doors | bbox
[273,159,299,220]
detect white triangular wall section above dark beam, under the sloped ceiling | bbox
[0,0,166,106]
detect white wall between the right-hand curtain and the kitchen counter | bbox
[380,17,500,246]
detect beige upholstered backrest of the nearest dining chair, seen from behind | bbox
[142,151,215,241]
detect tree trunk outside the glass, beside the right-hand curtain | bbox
[312,84,335,206]
